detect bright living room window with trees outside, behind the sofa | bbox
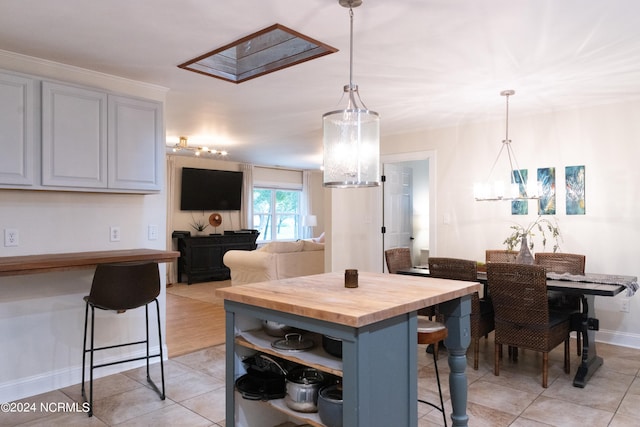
[253,187,302,242]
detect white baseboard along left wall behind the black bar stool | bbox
[0,345,168,403]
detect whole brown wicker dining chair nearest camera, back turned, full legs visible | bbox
[487,263,570,388]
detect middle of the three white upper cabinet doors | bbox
[42,82,107,188]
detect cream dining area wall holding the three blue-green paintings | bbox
[372,101,640,348]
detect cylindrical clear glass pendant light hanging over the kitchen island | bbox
[322,0,380,188]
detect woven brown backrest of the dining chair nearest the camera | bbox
[487,263,549,326]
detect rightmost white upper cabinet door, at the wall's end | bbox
[109,95,164,191]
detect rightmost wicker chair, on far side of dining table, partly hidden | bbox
[535,252,586,356]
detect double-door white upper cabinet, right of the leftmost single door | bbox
[37,81,164,193]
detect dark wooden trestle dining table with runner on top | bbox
[397,267,638,388]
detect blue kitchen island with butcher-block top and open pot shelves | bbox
[216,272,480,427]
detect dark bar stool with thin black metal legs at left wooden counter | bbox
[82,262,165,417]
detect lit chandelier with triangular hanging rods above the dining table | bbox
[473,89,541,201]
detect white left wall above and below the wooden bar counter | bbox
[0,51,166,402]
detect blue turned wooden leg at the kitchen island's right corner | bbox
[440,295,471,427]
